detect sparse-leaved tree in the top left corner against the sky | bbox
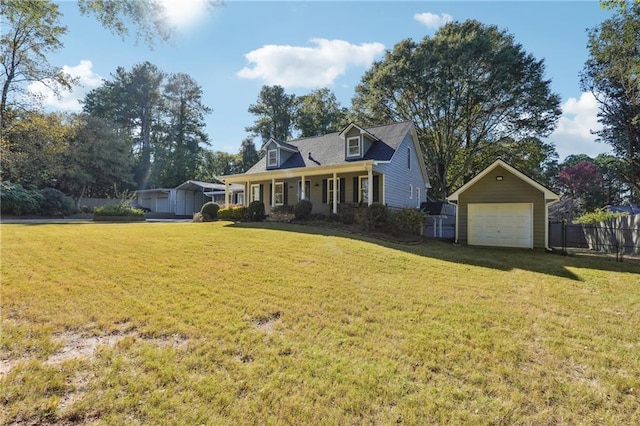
[0,0,73,130]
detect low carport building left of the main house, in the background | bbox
[136,180,244,217]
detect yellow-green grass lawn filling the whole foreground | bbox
[0,222,640,424]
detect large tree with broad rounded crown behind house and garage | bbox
[352,20,561,198]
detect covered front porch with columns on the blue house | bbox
[221,162,385,214]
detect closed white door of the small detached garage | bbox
[468,203,533,248]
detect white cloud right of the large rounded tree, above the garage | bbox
[549,93,611,161]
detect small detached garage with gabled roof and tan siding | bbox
[447,160,560,249]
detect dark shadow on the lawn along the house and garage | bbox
[227,222,640,281]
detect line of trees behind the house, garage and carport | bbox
[0,0,640,215]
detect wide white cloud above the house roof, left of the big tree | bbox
[237,38,384,89]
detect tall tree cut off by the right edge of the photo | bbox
[580,1,640,201]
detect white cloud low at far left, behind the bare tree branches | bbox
[27,59,103,112]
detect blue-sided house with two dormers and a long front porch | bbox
[220,121,430,214]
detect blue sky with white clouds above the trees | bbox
[31,0,610,160]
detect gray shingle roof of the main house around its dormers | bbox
[246,121,412,174]
